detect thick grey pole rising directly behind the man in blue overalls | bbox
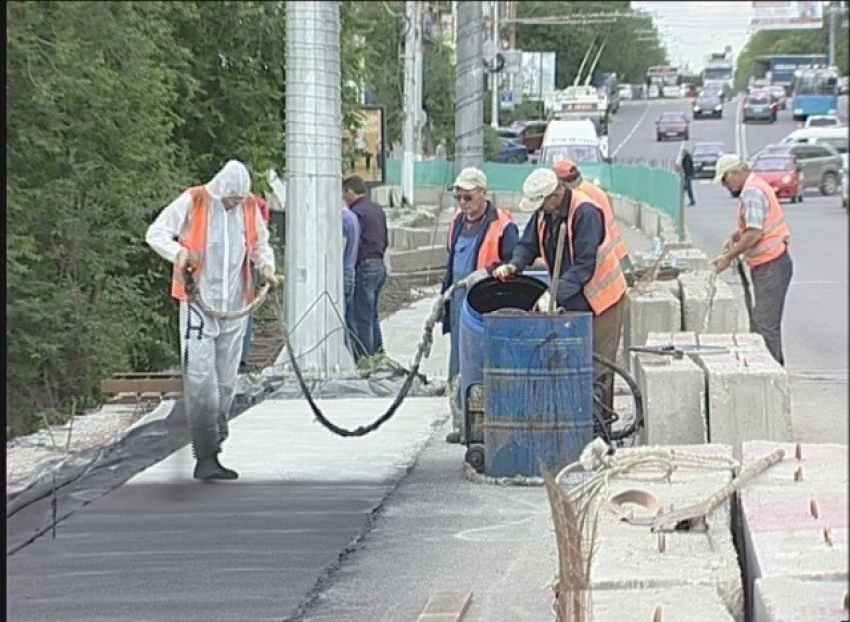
[455,0,484,172]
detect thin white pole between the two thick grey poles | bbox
[401,0,422,205]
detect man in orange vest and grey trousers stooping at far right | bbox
[712,153,794,365]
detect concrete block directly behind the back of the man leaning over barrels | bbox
[623,283,682,366]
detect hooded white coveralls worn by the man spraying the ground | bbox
[145,160,274,460]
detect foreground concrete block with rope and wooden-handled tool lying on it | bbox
[591,445,744,621]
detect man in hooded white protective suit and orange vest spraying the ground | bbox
[145,160,277,480]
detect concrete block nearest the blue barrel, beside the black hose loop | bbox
[631,332,708,445]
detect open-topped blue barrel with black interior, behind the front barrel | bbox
[458,273,547,424]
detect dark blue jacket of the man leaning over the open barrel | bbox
[510,188,605,311]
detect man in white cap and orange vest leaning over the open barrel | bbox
[493,168,628,416]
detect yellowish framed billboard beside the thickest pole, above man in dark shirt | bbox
[342,106,387,185]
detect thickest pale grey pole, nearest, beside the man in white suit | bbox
[277,0,354,377]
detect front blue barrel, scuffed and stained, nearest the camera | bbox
[483,313,593,477]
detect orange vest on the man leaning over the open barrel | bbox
[537,190,628,317]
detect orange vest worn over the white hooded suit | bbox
[171,186,258,304]
